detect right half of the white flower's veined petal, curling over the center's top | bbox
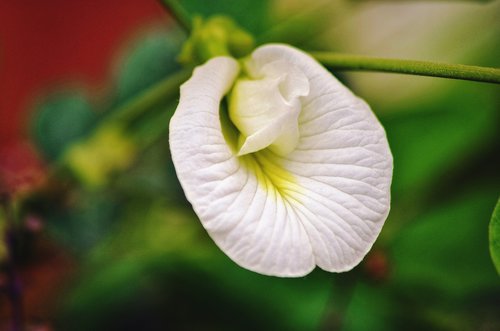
[248,45,392,271]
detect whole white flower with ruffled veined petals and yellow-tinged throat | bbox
[170,45,392,277]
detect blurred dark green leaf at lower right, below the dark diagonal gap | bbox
[390,187,500,301]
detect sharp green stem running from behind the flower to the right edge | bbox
[310,52,500,84]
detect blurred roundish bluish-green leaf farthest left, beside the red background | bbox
[32,90,97,160]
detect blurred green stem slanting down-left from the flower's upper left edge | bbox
[104,69,192,126]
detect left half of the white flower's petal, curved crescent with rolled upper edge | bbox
[170,57,315,276]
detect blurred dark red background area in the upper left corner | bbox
[0,0,168,192]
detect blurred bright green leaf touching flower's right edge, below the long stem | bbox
[380,81,500,199]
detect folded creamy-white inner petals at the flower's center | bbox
[229,59,309,155]
